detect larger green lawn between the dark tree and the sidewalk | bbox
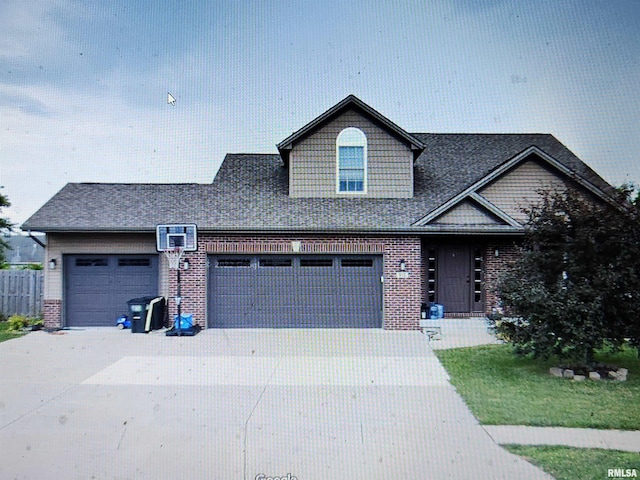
[435,345,640,430]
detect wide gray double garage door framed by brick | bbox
[208,255,382,328]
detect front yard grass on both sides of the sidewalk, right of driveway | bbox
[435,345,640,480]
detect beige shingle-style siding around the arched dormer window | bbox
[289,111,413,198]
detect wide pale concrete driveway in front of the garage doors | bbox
[0,328,551,480]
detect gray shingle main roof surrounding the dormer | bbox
[23,133,612,232]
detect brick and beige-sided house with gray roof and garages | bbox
[22,95,612,329]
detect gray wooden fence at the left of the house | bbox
[0,270,44,317]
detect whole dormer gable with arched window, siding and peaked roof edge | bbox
[277,95,425,198]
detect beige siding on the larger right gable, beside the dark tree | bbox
[479,160,566,222]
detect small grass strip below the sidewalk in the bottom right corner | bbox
[504,445,640,480]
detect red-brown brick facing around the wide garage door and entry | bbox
[44,233,518,330]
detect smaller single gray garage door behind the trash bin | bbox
[64,255,158,327]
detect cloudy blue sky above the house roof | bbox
[0,0,640,223]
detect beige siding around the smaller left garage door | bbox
[44,233,161,300]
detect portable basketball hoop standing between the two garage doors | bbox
[156,224,198,336]
